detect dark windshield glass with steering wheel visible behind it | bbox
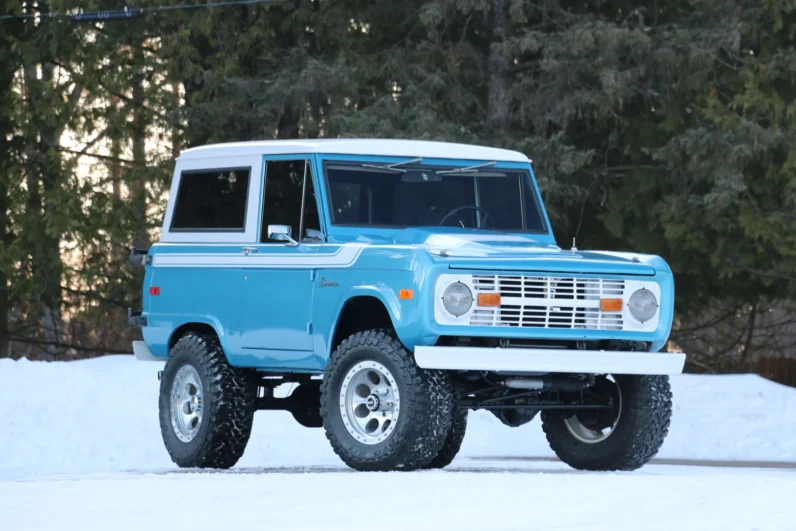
[326,162,545,232]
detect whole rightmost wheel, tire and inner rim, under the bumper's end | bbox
[542,375,672,470]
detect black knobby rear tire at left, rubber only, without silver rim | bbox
[159,332,257,468]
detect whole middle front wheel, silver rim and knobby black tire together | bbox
[321,330,453,471]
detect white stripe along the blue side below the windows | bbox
[153,244,366,268]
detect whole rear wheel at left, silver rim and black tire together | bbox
[159,332,257,468]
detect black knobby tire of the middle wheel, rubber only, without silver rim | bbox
[321,330,453,471]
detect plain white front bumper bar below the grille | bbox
[415,347,685,374]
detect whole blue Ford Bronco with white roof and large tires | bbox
[129,140,685,470]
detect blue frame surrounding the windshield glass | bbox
[319,155,552,237]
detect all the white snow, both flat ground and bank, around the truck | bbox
[0,356,796,531]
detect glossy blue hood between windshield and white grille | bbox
[394,229,655,276]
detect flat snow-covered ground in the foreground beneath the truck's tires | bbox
[0,464,796,531]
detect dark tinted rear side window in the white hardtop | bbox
[171,168,251,232]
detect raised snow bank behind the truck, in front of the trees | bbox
[0,356,796,478]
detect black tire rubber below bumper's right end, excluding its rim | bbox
[542,375,672,470]
